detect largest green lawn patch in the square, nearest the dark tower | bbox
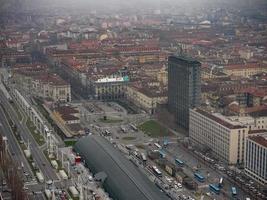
[138,120,172,137]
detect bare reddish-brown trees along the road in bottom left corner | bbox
[0,136,28,200]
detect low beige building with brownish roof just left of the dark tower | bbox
[126,85,167,114]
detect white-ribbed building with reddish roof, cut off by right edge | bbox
[245,132,267,185]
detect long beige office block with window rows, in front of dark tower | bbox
[189,109,249,165]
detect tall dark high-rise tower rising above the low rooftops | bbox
[168,56,201,130]
